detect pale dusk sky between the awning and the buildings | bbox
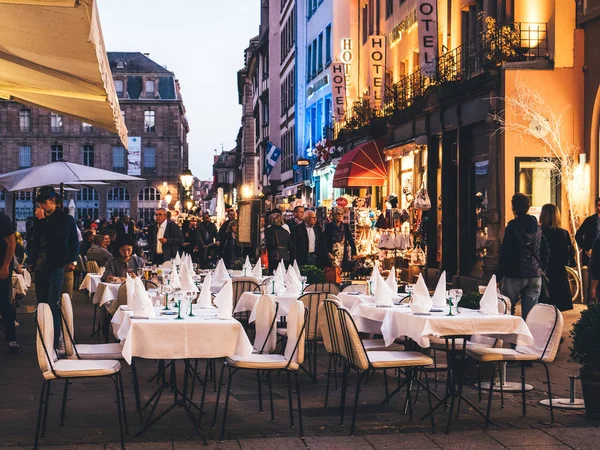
[98,0,260,180]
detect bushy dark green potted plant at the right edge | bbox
[570,303,600,420]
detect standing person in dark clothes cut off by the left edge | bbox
[0,212,21,353]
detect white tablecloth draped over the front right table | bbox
[354,304,533,348]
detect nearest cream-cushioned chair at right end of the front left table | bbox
[213,300,308,440]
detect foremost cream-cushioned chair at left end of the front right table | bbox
[338,308,435,434]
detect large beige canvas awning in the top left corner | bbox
[0,0,127,146]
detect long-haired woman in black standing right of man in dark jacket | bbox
[540,203,573,311]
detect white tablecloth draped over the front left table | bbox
[112,308,252,364]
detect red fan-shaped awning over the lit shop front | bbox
[333,141,387,188]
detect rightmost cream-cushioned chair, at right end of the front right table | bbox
[467,303,564,427]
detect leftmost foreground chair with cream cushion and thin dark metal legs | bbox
[34,303,125,449]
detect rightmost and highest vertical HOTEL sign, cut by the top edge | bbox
[417,0,438,77]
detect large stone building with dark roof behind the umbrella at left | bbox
[0,52,189,227]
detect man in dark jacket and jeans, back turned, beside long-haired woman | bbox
[496,193,550,319]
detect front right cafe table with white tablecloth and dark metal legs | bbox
[352,303,533,432]
